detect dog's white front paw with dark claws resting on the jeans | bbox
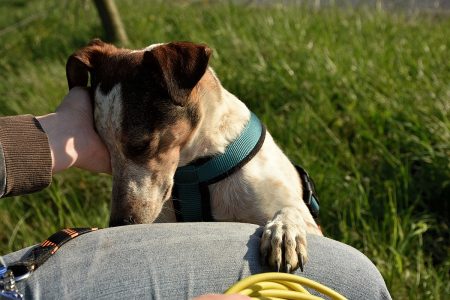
[260,208,308,273]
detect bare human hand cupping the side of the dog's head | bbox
[36,87,111,173]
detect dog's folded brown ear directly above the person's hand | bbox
[66,39,114,90]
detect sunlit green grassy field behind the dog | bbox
[0,0,450,299]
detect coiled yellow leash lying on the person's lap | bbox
[225,272,347,300]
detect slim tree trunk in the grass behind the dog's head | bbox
[94,0,128,46]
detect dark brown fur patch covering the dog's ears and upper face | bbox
[66,39,211,161]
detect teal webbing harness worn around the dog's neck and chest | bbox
[172,113,319,222]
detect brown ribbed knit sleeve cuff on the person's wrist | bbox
[0,115,52,197]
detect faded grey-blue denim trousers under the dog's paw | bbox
[3,223,390,299]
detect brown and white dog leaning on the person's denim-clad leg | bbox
[66,39,322,272]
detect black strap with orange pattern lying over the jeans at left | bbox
[8,228,98,281]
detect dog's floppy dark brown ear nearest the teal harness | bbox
[144,42,212,106]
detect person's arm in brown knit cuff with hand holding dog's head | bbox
[0,88,111,197]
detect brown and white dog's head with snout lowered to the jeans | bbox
[66,40,211,226]
